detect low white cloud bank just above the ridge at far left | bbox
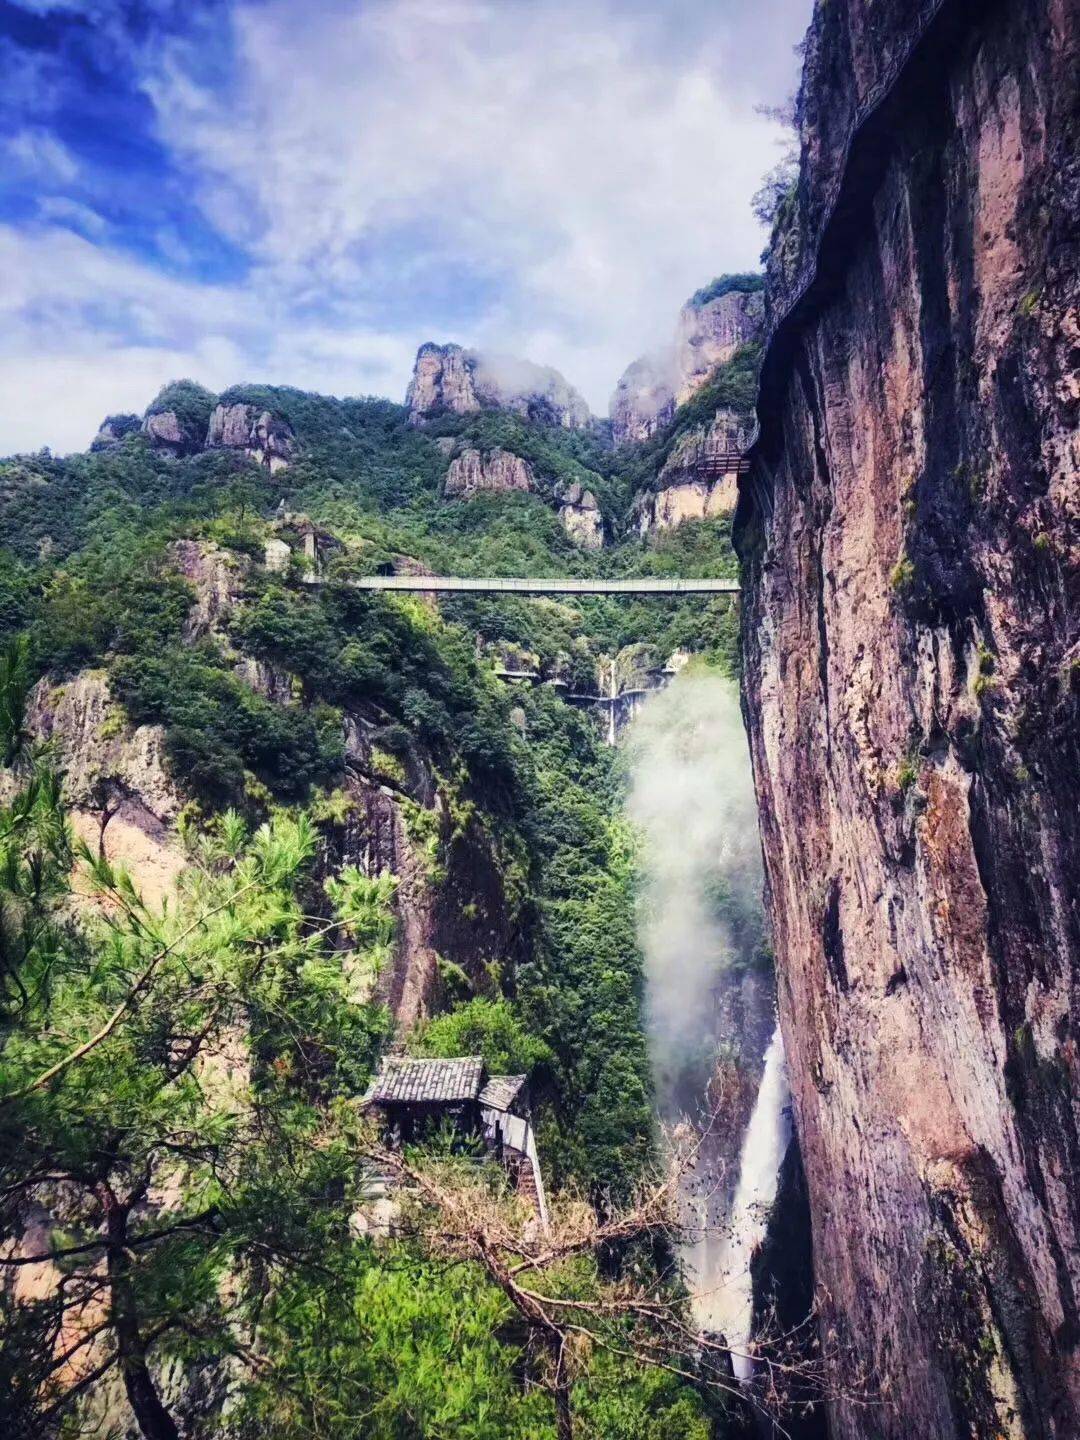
[0,226,412,455]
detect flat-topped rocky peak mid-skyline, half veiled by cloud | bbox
[405,343,592,431]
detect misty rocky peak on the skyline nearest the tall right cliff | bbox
[611,276,765,445]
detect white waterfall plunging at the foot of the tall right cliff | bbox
[687,1025,791,1382]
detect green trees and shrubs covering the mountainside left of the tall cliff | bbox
[0,345,756,1440]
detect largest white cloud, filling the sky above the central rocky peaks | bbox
[148,0,798,409]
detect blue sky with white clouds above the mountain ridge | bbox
[0,0,811,454]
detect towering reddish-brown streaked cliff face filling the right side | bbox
[736,0,1080,1440]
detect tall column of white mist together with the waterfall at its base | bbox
[626,672,791,1380]
